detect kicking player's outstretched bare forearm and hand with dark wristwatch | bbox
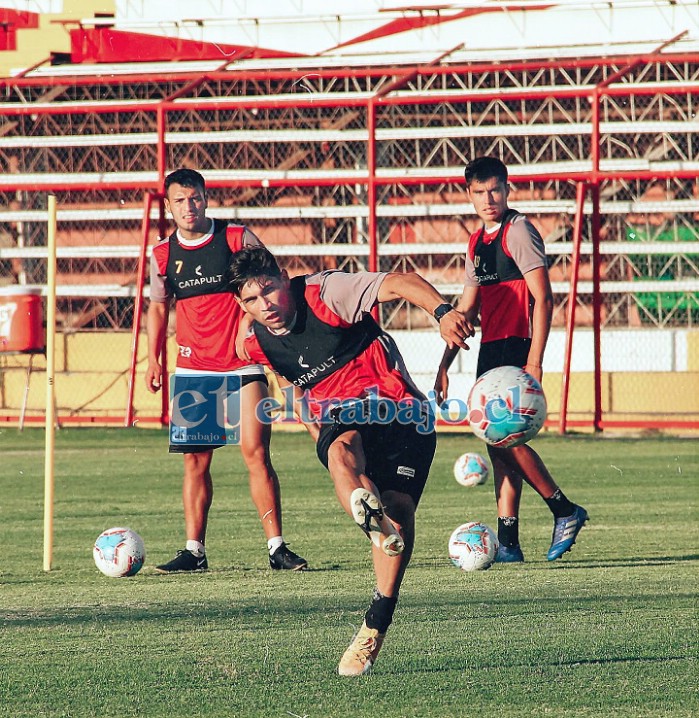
[377,273,474,349]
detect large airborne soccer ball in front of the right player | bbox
[468,366,546,449]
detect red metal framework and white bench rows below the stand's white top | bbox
[0,50,699,430]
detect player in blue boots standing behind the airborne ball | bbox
[435,157,587,563]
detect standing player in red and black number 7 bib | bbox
[145,169,307,573]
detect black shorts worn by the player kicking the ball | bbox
[316,402,437,506]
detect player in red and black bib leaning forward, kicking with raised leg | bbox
[228,247,473,676]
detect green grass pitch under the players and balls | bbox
[0,428,699,718]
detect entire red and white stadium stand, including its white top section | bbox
[0,0,699,428]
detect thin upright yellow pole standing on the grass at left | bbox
[44,194,56,571]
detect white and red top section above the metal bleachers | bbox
[13,0,699,77]
